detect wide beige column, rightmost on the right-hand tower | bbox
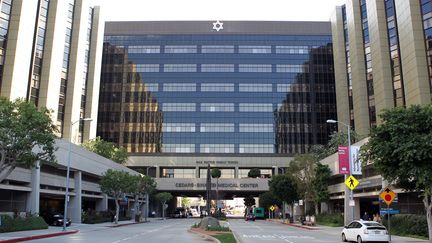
[395,0,431,106]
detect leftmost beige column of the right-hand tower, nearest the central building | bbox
[330,7,350,130]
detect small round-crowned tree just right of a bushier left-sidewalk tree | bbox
[130,175,156,221]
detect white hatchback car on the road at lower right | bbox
[341,220,390,243]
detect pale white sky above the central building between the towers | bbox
[90,0,345,21]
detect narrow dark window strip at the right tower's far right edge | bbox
[419,0,432,92]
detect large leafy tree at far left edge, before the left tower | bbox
[0,97,56,182]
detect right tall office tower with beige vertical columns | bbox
[331,0,432,135]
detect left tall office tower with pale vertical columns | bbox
[0,0,104,142]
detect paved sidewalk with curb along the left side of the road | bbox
[0,218,160,243]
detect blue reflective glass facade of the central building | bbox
[97,29,336,154]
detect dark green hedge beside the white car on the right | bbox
[383,214,428,237]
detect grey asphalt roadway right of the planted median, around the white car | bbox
[228,219,426,243]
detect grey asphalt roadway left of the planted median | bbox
[32,219,208,243]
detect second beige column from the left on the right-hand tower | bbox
[346,0,370,135]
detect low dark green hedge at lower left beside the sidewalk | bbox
[0,215,48,233]
